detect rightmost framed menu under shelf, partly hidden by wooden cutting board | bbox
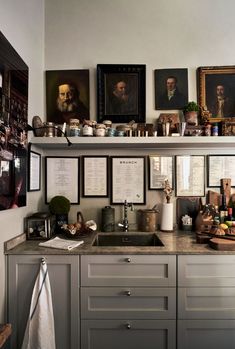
[207,155,235,187]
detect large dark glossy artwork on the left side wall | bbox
[0,32,28,210]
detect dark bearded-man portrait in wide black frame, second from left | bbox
[97,64,146,123]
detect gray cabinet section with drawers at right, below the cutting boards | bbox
[178,255,235,349]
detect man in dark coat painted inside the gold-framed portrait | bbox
[207,84,235,118]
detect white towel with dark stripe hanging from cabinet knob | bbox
[21,259,56,349]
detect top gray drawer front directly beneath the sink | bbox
[81,255,176,287]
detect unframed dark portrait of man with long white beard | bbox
[46,69,90,124]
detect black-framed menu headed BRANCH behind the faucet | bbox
[111,156,146,204]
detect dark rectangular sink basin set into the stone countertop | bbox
[92,232,164,246]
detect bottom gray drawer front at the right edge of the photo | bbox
[178,320,235,349]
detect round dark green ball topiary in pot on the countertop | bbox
[49,195,70,233]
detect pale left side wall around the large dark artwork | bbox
[0,0,44,323]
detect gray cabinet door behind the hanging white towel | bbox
[8,255,79,349]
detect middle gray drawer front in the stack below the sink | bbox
[81,287,176,319]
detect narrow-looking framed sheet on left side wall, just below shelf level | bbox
[28,150,41,191]
